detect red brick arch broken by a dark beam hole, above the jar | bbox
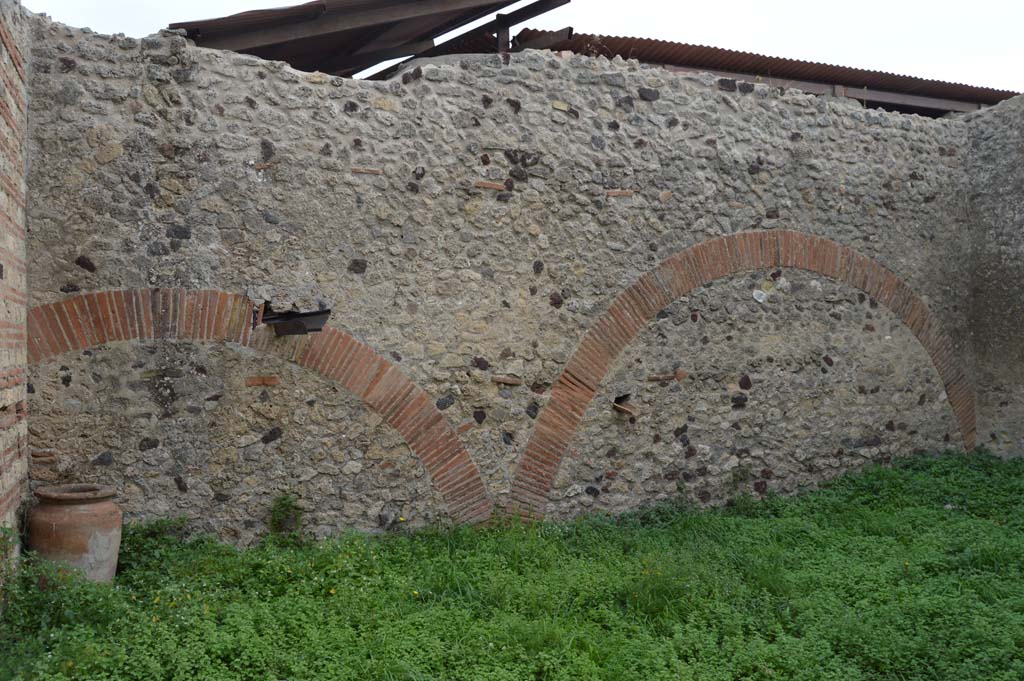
[28,289,493,523]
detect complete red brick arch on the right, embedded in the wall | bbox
[511,230,975,516]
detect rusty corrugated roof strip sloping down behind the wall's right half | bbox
[516,29,1018,104]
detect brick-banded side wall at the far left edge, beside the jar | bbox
[0,2,29,558]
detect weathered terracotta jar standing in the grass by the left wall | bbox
[29,484,122,582]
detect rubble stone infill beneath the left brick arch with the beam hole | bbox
[32,341,446,545]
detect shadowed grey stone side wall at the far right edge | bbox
[968,97,1024,455]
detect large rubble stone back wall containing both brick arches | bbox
[16,9,1019,544]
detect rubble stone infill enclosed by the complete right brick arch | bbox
[547,269,956,517]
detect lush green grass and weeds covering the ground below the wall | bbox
[0,455,1024,681]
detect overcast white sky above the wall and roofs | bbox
[23,0,1024,92]
